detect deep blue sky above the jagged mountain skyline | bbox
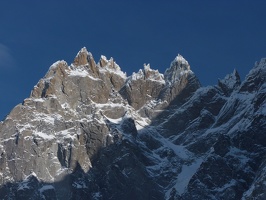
[0,0,266,119]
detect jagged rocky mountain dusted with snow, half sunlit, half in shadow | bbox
[0,48,266,200]
